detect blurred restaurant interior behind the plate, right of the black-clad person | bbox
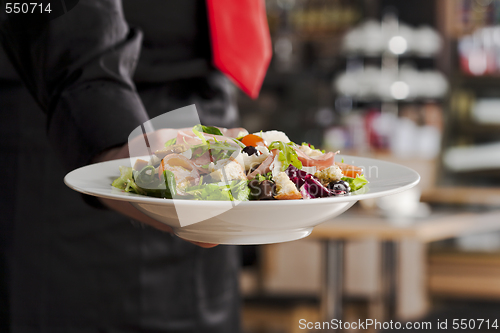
[239,0,500,332]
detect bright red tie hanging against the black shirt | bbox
[207,0,272,98]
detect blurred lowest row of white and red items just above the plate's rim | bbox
[323,102,443,160]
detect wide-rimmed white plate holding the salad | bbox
[64,156,420,244]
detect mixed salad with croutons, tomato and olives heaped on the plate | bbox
[112,125,368,201]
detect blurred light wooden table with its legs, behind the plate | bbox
[309,209,500,320]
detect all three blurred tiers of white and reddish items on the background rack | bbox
[324,12,448,161]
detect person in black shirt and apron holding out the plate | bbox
[0,0,269,333]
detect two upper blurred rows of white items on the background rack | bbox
[333,11,448,103]
